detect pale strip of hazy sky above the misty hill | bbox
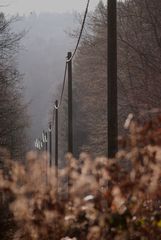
[1,0,106,14]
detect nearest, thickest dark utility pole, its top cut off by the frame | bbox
[107,0,118,158]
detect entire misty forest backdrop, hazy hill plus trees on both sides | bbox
[0,0,161,161]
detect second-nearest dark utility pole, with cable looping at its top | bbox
[67,52,73,153]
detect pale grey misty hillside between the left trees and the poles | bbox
[15,13,78,148]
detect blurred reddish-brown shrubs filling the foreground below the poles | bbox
[0,116,161,240]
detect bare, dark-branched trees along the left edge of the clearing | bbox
[0,13,28,158]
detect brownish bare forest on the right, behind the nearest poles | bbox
[70,0,161,154]
